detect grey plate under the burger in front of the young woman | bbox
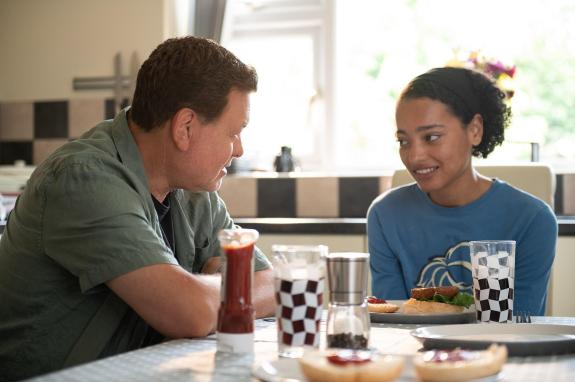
[369,300,477,325]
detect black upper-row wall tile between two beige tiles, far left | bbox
[34,101,68,138]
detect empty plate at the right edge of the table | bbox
[411,324,575,356]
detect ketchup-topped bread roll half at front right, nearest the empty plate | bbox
[413,344,507,382]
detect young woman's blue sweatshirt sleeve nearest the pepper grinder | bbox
[367,198,408,299]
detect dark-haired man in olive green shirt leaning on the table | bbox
[0,37,273,380]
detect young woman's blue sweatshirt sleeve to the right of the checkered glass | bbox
[514,205,558,316]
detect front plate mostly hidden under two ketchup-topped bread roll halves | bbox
[252,357,503,382]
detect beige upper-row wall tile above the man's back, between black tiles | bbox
[68,99,105,138]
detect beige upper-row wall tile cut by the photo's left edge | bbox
[0,102,34,141]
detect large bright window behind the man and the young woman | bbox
[223,0,575,172]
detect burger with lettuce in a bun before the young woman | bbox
[403,286,474,314]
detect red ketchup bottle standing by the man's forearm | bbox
[217,229,259,353]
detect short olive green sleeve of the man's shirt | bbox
[39,162,177,292]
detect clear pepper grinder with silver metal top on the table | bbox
[326,252,370,350]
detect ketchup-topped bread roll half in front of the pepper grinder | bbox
[299,351,404,382]
